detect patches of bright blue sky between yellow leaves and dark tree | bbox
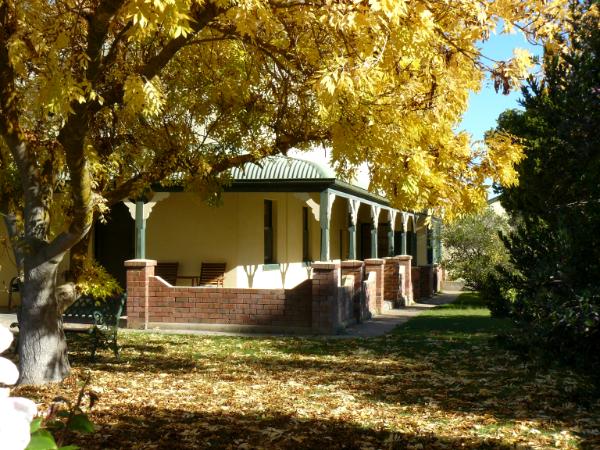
[459,34,542,140]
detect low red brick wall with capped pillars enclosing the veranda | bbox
[126,259,398,334]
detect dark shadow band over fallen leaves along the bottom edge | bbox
[70,406,514,450]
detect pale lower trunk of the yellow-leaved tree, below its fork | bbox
[18,256,71,384]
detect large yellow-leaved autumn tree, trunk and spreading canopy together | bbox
[0,0,567,383]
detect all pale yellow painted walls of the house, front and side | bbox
[0,186,434,306]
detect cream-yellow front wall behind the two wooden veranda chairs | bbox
[146,192,320,288]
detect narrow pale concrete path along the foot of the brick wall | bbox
[0,291,460,339]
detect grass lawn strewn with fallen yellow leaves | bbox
[16,294,600,449]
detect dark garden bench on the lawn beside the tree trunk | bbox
[63,294,127,359]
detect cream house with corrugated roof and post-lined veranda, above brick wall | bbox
[0,156,441,332]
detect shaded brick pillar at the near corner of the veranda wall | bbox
[312,262,340,334]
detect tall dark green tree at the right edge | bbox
[492,2,600,364]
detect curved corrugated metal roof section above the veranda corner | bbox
[231,156,335,181]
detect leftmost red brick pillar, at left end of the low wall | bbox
[125,259,156,329]
